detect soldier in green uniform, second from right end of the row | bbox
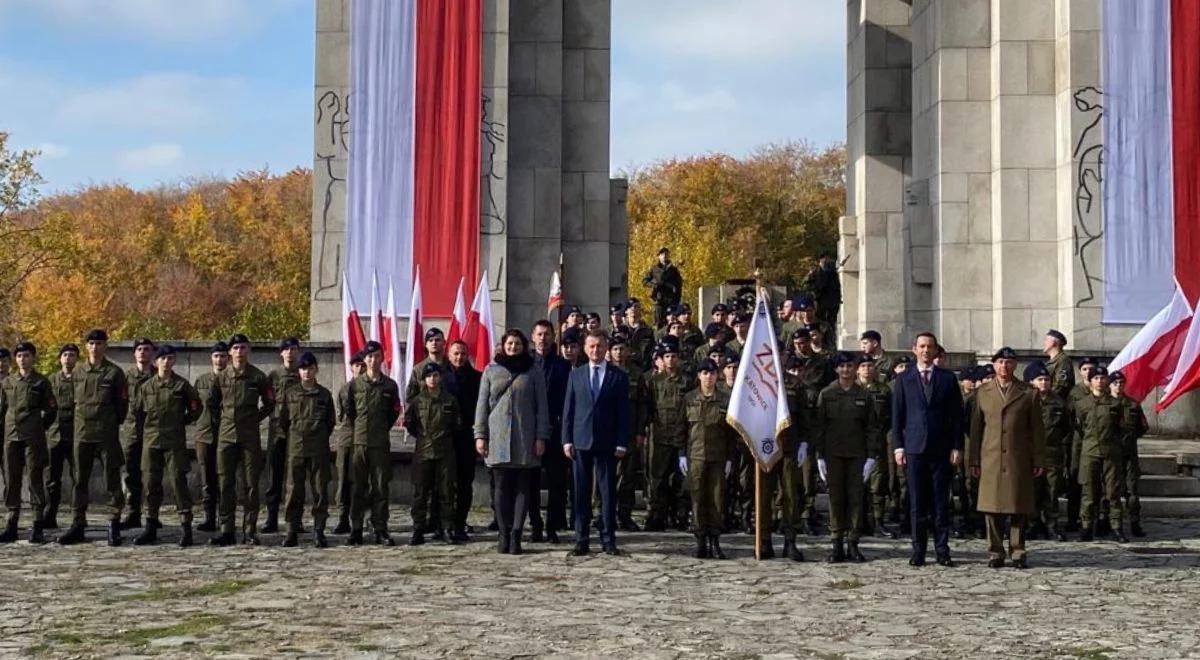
[1075,366,1129,542]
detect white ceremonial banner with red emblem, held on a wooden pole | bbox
[726,292,792,472]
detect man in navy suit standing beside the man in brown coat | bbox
[892,332,964,566]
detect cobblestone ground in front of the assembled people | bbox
[0,520,1200,659]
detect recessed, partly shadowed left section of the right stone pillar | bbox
[838,0,912,347]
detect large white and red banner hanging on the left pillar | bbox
[344,0,482,324]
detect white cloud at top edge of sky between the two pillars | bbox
[613,0,846,60]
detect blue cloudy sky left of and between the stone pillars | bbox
[0,0,845,192]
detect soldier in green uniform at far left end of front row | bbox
[0,342,59,544]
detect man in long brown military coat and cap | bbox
[968,347,1045,569]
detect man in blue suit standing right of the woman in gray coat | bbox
[563,332,630,557]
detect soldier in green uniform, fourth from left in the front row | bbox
[208,335,276,546]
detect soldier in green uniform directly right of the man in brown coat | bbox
[1025,365,1074,541]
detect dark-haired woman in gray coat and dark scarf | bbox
[475,330,550,554]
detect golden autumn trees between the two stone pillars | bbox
[626,142,846,304]
